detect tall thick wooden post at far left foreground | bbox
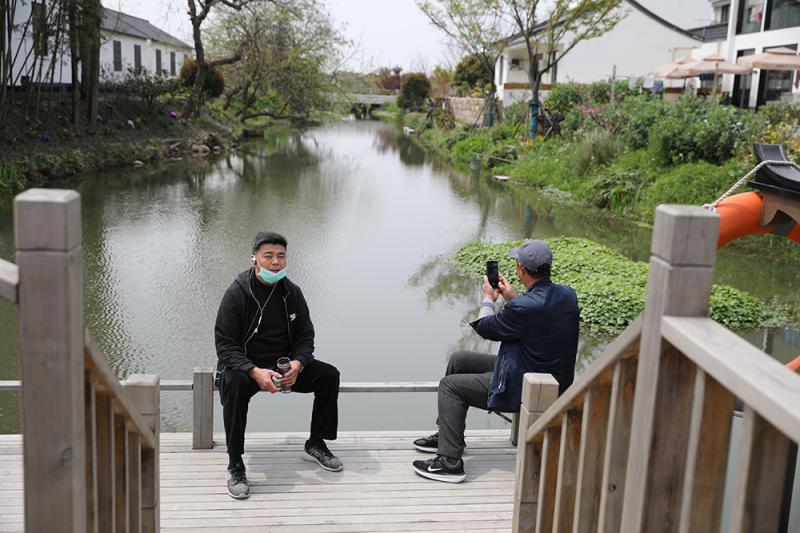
[14,189,86,533]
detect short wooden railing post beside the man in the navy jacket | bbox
[513,373,558,532]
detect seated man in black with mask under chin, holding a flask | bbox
[214,233,342,499]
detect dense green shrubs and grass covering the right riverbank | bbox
[394,86,800,230]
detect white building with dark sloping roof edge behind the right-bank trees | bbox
[495,0,706,105]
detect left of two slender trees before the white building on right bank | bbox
[416,0,513,125]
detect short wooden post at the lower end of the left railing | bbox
[125,374,161,533]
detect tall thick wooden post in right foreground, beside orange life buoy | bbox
[621,205,719,533]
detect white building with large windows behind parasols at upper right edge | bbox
[692,0,800,108]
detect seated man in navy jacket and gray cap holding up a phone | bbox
[413,241,579,483]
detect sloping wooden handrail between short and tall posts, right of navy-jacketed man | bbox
[526,315,642,442]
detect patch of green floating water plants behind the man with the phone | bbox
[455,237,789,336]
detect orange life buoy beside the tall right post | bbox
[717,192,800,249]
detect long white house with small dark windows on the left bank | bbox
[5,0,193,86]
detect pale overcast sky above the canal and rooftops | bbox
[102,0,712,72]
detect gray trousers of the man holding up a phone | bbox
[436,352,497,459]
